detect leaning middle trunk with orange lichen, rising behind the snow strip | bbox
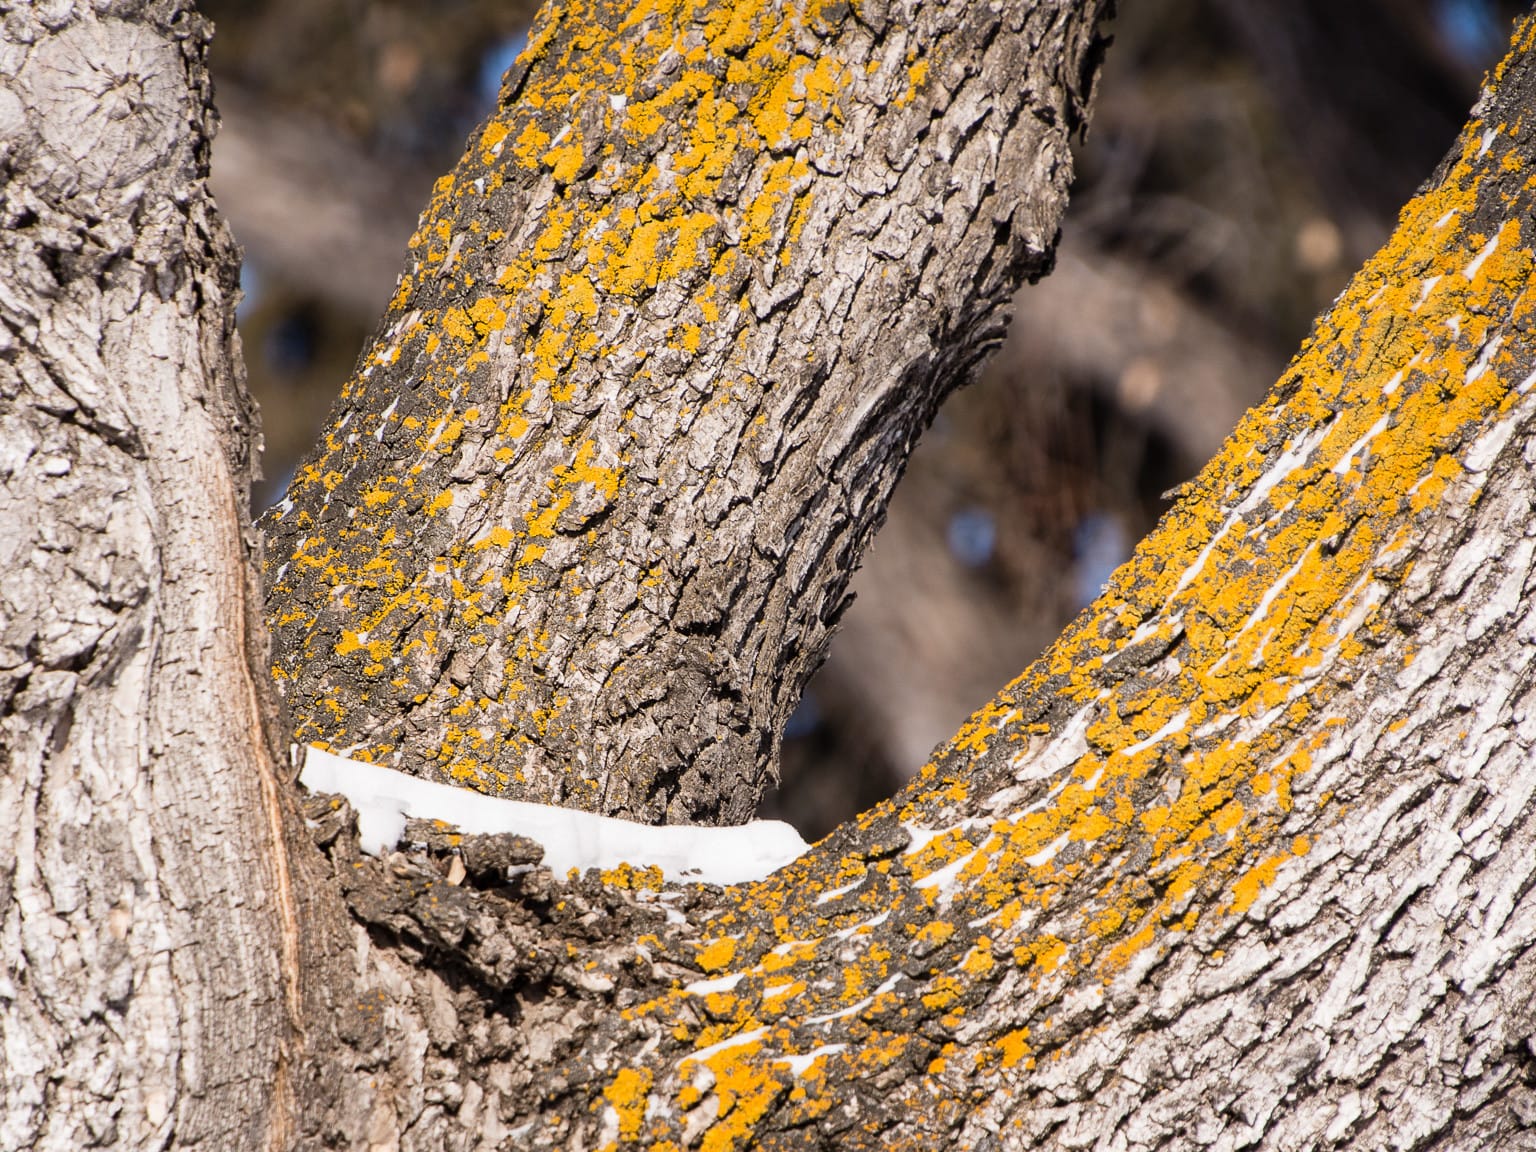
[266,0,1104,823]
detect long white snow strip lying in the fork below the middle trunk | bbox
[300,745,809,885]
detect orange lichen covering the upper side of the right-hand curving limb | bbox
[602,36,1536,1136]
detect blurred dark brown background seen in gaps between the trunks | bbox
[203,0,1525,837]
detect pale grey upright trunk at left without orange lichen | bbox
[0,2,298,1149]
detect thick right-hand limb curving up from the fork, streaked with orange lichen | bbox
[276,22,1536,1152]
